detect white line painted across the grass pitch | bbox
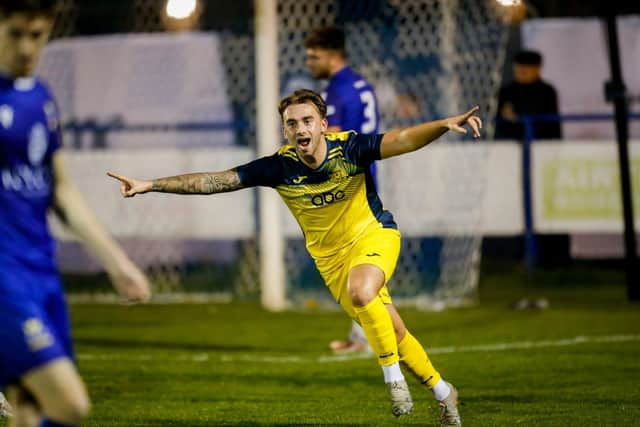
[78,335,640,363]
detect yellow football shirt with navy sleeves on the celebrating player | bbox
[236,131,397,260]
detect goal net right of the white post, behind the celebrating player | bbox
[278,0,506,309]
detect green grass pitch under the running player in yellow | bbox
[0,266,640,427]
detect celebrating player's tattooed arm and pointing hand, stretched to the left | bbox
[107,169,244,197]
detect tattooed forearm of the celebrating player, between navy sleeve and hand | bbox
[152,169,244,194]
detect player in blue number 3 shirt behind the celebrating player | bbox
[304,27,380,353]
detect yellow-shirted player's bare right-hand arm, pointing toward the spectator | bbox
[380,107,482,159]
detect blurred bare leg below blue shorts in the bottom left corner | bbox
[14,358,90,427]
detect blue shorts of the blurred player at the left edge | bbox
[0,265,73,390]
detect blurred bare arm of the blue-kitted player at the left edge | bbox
[53,151,151,302]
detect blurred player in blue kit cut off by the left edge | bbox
[0,0,150,427]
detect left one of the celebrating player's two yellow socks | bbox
[353,298,400,366]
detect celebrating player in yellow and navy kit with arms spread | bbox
[108,89,482,426]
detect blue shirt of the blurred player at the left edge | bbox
[0,75,60,278]
